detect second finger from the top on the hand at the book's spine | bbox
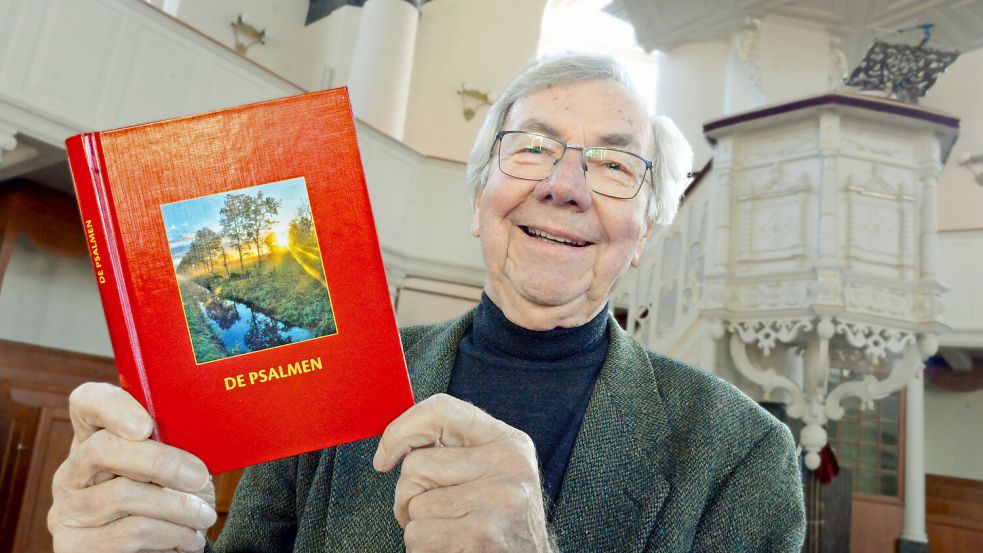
[67,430,209,492]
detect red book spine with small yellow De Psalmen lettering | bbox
[65,133,159,439]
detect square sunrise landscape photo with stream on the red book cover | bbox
[161,177,337,364]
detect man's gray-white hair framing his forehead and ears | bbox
[466,54,693,225]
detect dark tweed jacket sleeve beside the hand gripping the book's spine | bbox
[205,457,298,553]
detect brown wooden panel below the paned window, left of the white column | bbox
[850,494,904,553]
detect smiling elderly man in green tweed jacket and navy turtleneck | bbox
[49,52,805,553]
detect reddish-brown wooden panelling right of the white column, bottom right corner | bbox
[925,474,983,553]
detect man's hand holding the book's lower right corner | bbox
[372,394,550,553]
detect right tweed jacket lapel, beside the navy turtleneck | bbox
[553,317,669,552]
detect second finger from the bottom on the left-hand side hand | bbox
[57,478,216,530]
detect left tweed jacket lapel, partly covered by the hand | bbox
[324,311,473,552]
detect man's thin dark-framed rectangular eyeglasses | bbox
[495,131,652,200]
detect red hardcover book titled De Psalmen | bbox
[66,89,413,473]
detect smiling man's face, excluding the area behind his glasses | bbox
[472,80,652,330]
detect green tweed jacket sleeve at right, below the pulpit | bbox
[692,425,806,553]
